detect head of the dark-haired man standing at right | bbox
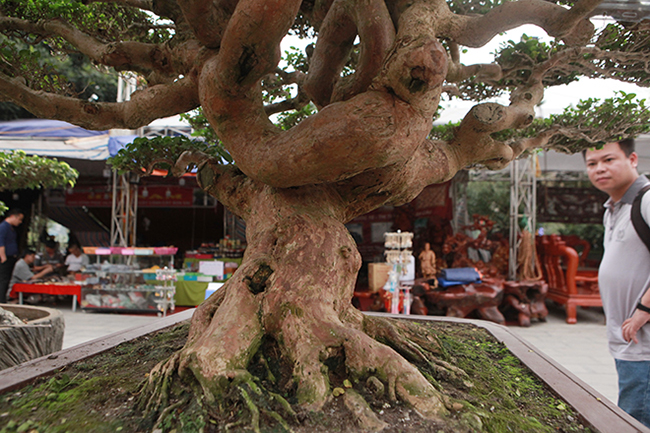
[585,143,639,201]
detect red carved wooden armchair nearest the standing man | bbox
[537,235,603,323]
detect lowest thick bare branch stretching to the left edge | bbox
[0,74,199,130]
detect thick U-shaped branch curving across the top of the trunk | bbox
[200,3,447,188]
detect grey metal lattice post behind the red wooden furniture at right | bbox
[508,154,537,280]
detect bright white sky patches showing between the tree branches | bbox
[282,18,650,124]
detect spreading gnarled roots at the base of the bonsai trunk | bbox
[138,306,472,433]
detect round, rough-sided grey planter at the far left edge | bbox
[0,304,65,370]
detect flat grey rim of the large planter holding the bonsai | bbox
[0,310,650,433]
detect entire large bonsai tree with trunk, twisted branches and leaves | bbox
[0,0,650,430]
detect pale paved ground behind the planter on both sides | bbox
[46,302,617,402]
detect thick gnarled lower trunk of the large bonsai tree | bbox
[140,180,446,428]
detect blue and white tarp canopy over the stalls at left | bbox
[0,119,137,161]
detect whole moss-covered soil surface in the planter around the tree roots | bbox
[0,322,591,433]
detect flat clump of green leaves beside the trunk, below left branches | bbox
[108,136,232,175]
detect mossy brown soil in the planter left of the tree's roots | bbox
[0,325,189,433]
